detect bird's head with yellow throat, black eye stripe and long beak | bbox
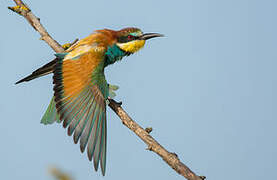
[113,28,163,53]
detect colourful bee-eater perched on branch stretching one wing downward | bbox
[15,27,163,176]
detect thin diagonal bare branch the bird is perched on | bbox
[8,0,205,180]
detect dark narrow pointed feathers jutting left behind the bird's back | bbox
[15,58,58,84]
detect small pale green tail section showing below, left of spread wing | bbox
[40,97,61,125]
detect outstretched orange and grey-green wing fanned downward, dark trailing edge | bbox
[53,44,109,175]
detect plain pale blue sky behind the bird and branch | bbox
[0,0,277,180]
